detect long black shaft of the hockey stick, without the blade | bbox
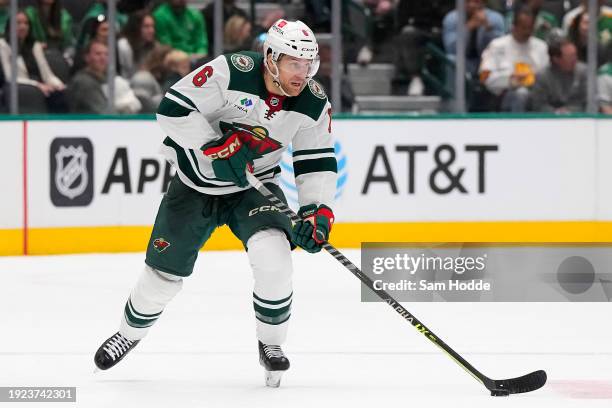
[246,171,487,384]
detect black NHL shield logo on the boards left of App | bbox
[49,137,93,207]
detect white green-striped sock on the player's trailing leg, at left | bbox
[119,265,183,340]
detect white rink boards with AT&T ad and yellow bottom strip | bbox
[0,117,612,255]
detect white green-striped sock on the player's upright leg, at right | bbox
[247,229,293,345]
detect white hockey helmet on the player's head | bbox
[263,19,319,78]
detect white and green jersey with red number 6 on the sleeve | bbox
[157,51,337,209]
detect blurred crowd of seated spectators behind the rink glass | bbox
[0,0,612,114]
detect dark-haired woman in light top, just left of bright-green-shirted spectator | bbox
[117,11,160,79]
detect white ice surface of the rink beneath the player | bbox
[0,250,612,408]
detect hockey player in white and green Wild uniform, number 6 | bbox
[94,20,337,387]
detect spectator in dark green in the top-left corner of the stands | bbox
[25,0,74,51]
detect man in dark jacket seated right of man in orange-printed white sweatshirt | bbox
[532,38,587,114]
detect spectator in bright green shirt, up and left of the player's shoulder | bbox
[153,0,208,60]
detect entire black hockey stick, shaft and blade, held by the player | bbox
[246,171,546,397]
